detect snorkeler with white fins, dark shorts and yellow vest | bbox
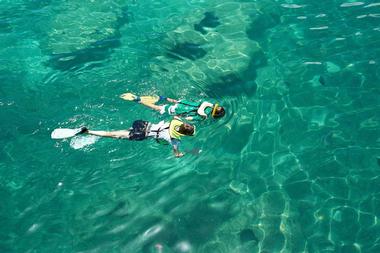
[51,118,195,157]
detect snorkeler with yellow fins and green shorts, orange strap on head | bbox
[120,93,225,121]
